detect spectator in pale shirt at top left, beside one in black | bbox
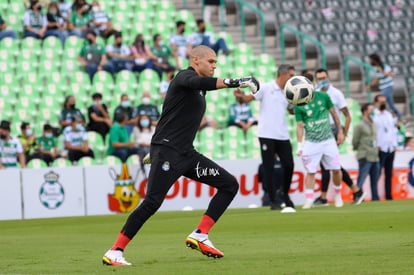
[23,1,47,39]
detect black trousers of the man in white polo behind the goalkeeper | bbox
[259,138,294,203]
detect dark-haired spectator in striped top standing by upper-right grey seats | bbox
[367,53,403,120]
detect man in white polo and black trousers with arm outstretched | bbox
[235,64,295,210]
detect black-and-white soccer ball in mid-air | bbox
[283,75,314,106]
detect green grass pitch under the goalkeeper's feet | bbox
[0,200,414,275]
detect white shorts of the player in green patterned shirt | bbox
[302,139,341,173]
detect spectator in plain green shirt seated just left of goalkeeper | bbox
[106,112,138,162]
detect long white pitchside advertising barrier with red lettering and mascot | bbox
[0,152,414,220]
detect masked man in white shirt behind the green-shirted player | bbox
[314,68,366,205]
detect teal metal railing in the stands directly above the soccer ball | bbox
[279,24,326,68]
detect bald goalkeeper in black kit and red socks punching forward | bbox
[102,46,259,265]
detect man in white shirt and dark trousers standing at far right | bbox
[374,95,398,200]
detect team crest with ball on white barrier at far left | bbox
[39,171,65,209]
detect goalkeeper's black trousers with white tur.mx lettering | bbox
[121,145,239,239]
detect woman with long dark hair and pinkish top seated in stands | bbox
[131,34,156,72]
